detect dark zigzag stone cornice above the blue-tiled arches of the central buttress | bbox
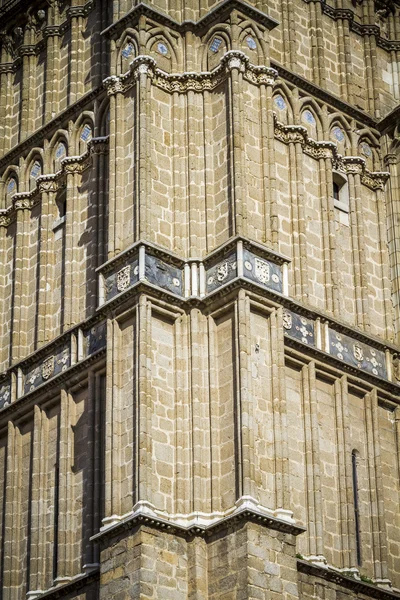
[102,0,279,39]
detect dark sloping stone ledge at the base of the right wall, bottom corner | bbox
[297,560,400,600]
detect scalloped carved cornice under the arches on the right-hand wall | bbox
[274,116,390,190]
